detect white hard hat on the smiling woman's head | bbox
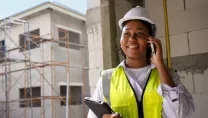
[118,6,156,36]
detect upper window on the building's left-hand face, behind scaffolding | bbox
[19,29,40,52]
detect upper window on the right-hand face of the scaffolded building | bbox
[58,29,80,50]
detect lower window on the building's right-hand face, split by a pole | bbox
[60,86,82,106]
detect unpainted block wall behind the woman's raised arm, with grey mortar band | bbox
[145,0,208,118]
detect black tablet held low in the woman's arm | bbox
[84,97,115,118]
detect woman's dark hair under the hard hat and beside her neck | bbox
[121,20,154,64]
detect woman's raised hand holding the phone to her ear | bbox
[148,37,164,68]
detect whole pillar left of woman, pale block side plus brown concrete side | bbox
[86,0,119,96]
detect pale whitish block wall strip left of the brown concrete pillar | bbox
[86,0,103,96]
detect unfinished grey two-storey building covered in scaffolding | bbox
[0,2,89,118]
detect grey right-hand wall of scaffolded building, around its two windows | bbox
[51,11,89,118]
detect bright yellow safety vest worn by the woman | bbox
[103,66,163,118]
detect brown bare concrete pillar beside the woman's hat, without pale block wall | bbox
[101,0,119,69]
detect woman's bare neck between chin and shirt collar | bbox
[125,58,148,68]
